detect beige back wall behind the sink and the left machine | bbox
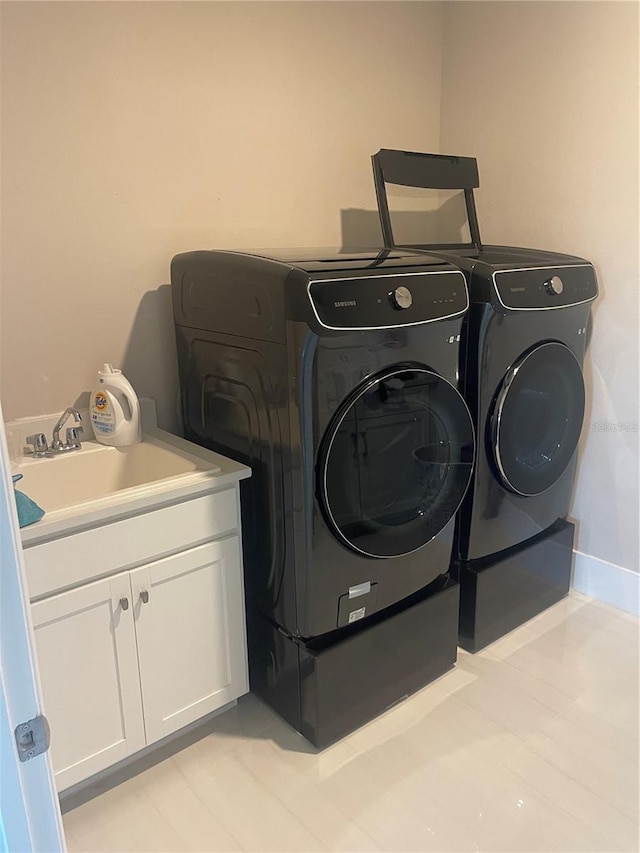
[0,2,442,427]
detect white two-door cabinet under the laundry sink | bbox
[25,489,249,791]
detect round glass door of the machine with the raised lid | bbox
[490,342,585,497]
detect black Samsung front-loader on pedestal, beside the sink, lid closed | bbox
[171,249,474,747]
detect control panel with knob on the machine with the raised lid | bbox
[493,264,598,311]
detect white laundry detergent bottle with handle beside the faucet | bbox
[91,364,142,447]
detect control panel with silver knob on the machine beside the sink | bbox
[307,269,469,330]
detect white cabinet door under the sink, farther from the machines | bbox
[31,573,145,791]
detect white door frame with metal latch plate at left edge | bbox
[0,406,65,853]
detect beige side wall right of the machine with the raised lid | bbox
[441,2,639,571]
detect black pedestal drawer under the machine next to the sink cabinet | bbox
[250,576,459,749]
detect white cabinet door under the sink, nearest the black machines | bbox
[131,536,248,743]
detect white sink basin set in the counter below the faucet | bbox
[14,439,220,512]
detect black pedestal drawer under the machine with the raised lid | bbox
[452,521,575,652]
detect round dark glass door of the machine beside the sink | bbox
[317,366,474,558]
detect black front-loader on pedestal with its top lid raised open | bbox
[373,149,598,651]
